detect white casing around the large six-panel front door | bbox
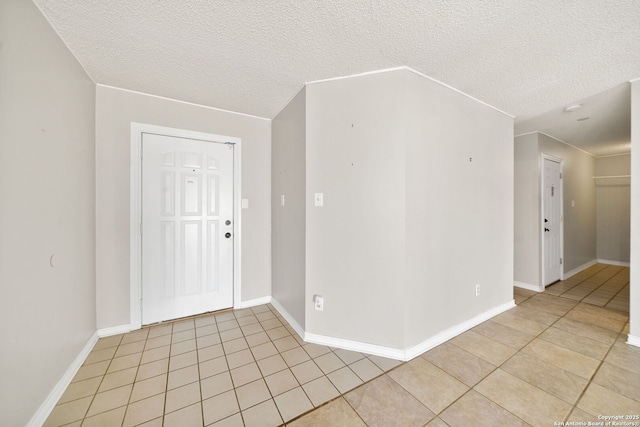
[129,122,242,330]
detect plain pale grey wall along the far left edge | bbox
[0,0,96,426]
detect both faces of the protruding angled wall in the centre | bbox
[305,69,513,350]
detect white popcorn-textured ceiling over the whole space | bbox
[35,0,640,154]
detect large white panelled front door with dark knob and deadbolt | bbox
[142,133,234,324]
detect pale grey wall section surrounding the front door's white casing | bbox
[96,85,271,328]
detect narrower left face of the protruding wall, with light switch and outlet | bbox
[305,71,405,348]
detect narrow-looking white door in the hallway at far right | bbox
[542,158,562,286]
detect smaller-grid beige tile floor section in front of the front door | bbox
[45,305,400,426]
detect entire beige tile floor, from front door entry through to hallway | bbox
[45,265,640,427]
